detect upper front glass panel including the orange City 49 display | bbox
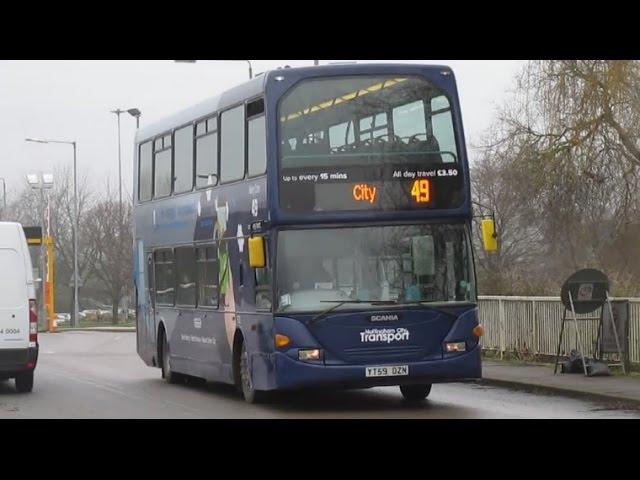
[278,76,464,212]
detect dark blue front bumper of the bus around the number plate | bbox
[275,346,482,390]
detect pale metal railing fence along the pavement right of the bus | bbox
[478,296,640,363]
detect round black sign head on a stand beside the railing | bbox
[560,268,609,313]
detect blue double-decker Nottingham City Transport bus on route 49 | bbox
[133,64,495,403]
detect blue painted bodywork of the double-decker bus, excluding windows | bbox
[133,65,481,390]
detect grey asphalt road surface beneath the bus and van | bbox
[0,332,640,419]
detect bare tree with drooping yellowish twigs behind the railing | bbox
[473,60,640,294]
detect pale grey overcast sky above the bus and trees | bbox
[0,60,525,200]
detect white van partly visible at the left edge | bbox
[0,222,38,392]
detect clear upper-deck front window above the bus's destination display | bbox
[278,76,458,168]
